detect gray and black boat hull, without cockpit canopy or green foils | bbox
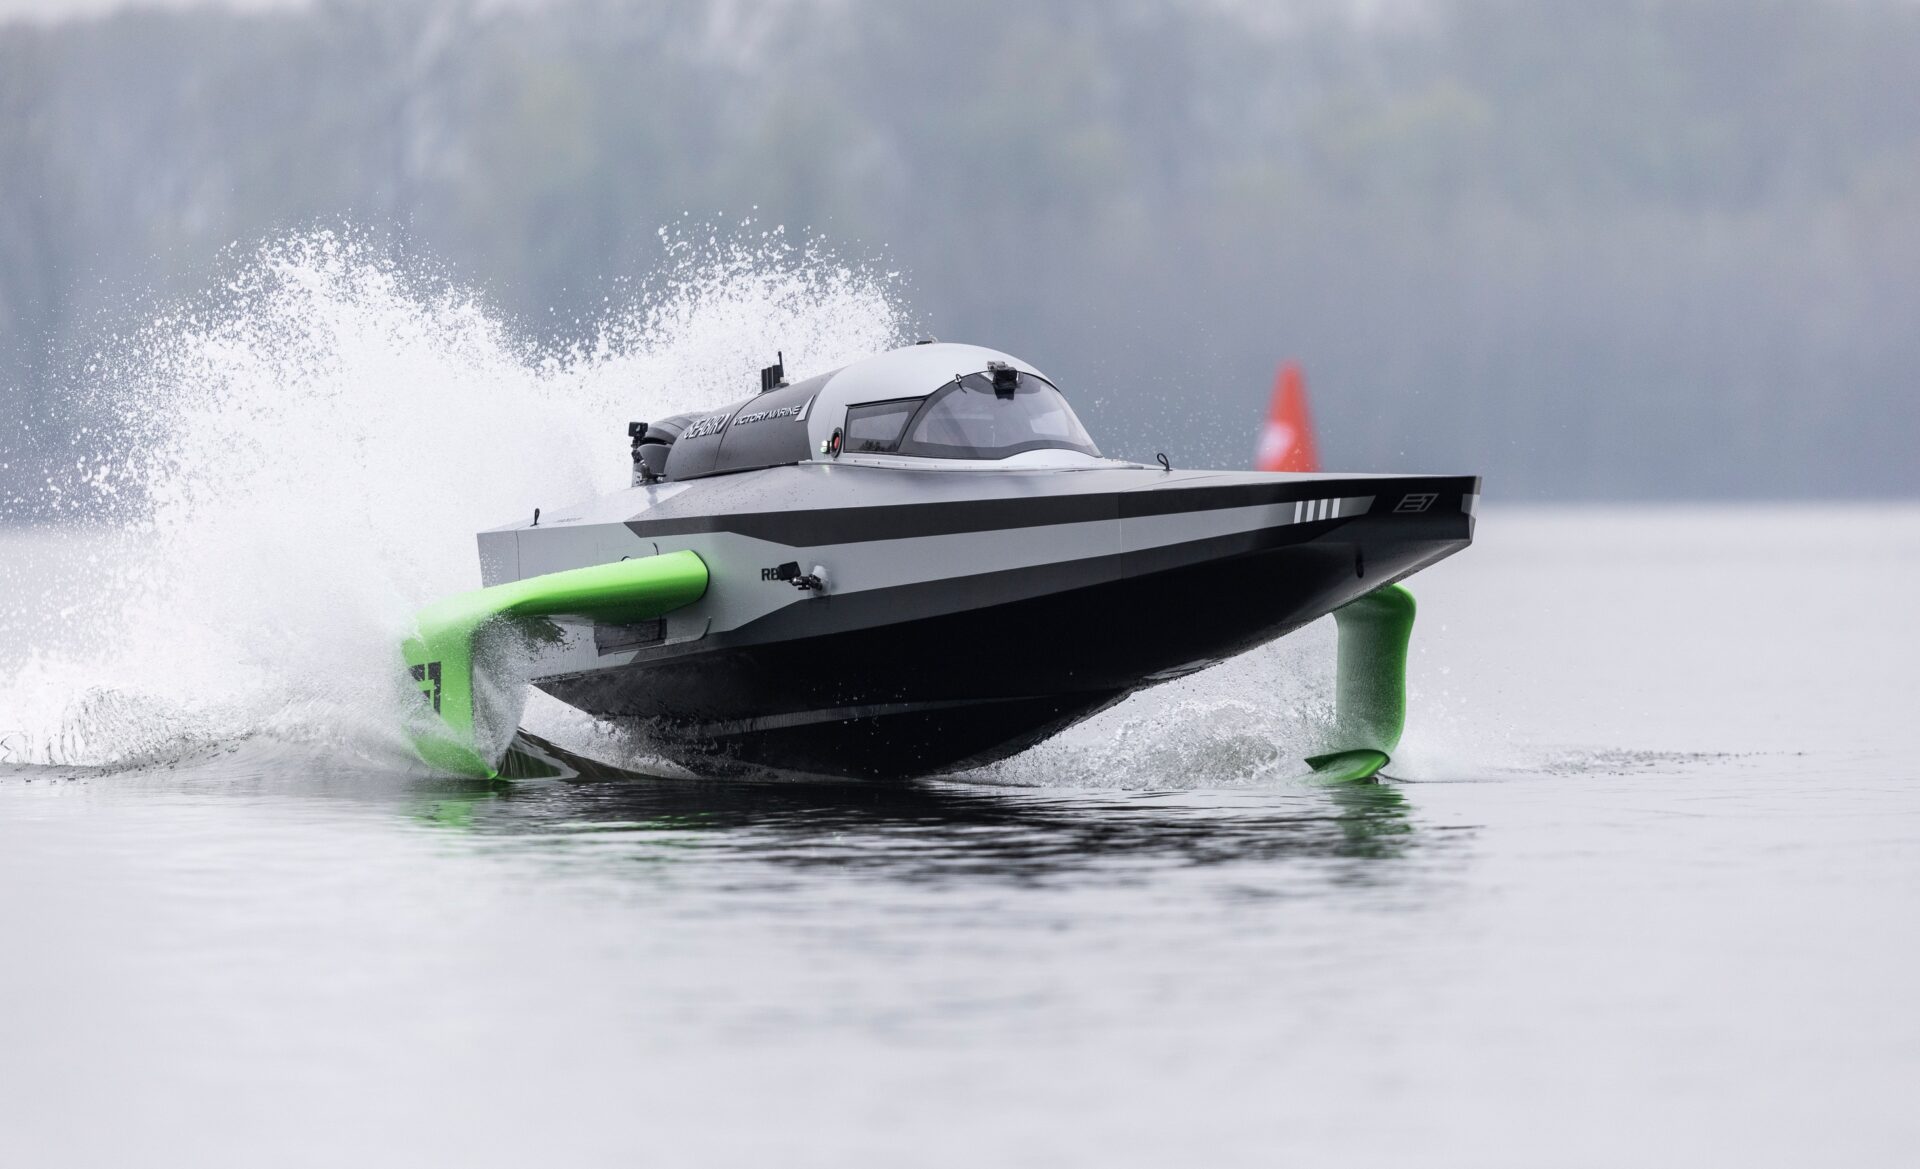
[503,468,1478,777]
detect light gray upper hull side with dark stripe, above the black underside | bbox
[480,465,1476,664]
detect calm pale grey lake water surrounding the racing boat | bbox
[0,507,1920,1167]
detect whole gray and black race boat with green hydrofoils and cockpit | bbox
[405,342,1480,779]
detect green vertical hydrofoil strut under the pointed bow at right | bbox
[1308,585,1415,783]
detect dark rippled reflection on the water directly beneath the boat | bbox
[409,777,1421,883]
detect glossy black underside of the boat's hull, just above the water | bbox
[540,514,1473,779]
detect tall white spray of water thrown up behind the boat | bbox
[0,225,912,768]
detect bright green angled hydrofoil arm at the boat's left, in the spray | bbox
[401,551,708,779]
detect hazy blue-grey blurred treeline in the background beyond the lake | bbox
[0,0,1920,497]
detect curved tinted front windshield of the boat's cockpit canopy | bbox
[899,370,1100,459]
